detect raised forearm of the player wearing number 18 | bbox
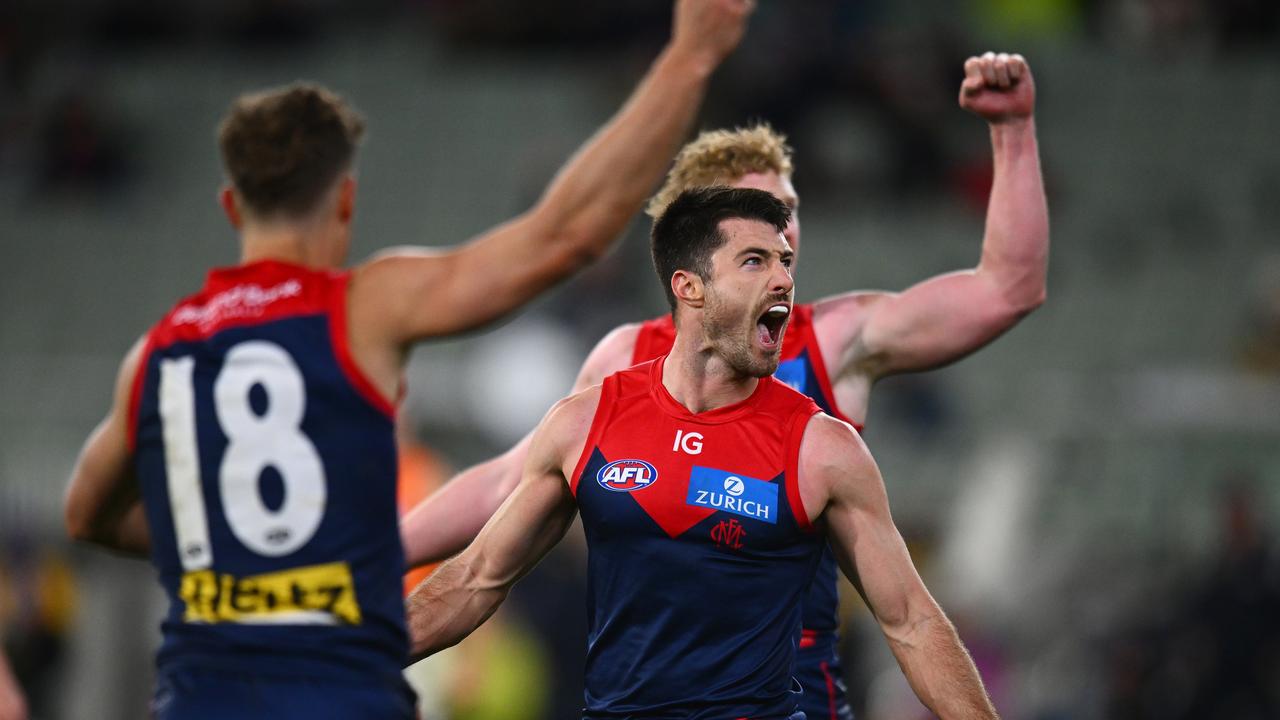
[535,44,717,251]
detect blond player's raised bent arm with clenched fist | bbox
[814,53,1048,379]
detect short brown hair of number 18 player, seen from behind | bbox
[218,82,365,217]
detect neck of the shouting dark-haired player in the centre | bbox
[662,333,760,413]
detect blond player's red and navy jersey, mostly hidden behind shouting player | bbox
[631,304,863,632]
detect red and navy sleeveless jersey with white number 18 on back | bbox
[129,261,408,683]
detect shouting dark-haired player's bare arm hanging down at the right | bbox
[800,415,996,720]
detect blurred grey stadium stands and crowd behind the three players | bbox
[0,0,1280,720]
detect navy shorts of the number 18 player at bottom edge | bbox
[151,669,417,720]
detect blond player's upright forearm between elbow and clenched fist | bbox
[978,117,1048,309]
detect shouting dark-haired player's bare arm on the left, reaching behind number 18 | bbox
[406,391,599,661]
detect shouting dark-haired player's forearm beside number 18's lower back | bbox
[404,556,509,662]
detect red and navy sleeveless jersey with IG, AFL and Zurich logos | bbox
[571,359,824,720]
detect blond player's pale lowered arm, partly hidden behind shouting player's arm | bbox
[401,324,640,568]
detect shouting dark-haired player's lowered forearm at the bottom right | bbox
[884,610,997,720]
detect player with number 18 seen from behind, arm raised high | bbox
[65,0,753,720]
